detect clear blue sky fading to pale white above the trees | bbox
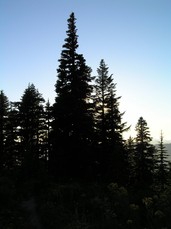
[0,0,171,142]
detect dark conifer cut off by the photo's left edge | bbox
[0,91,19,170]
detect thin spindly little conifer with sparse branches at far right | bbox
[157,132,169,191]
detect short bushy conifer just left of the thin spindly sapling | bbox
[135,117,155,188]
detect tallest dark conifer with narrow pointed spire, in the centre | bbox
[52,13,92,180]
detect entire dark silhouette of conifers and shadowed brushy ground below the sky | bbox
[0,13,171,229]
